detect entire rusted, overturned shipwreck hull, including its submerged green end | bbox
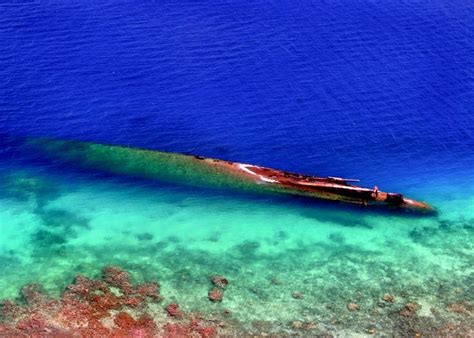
[27,139,434,212]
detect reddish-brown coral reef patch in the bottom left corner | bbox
[0,266,218,337]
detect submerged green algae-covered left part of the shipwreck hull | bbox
[27,139,262,190]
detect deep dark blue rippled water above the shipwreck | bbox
[0,1,474,193]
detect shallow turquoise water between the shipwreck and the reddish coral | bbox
[0,149,474,334]
